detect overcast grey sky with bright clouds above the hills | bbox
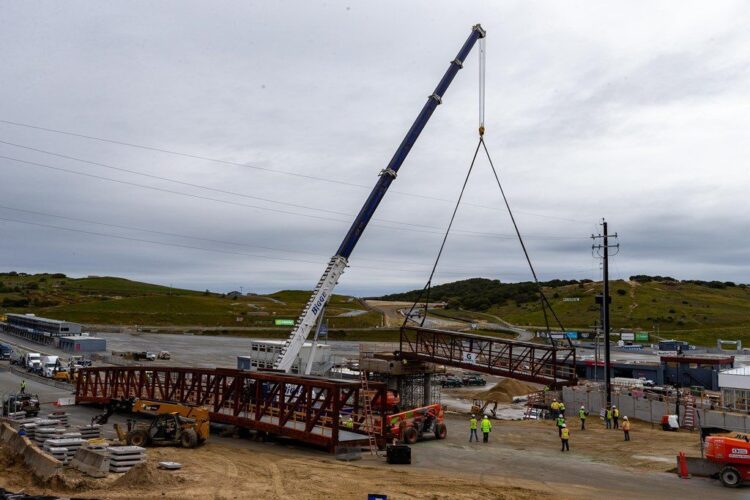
[0,0,750,295]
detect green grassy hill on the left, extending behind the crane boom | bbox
[0,273,382,334]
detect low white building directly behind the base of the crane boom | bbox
[237,340,333,376]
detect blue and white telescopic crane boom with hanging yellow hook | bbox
[274,24,486,373]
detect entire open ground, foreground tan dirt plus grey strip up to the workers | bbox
[0,416,722,500]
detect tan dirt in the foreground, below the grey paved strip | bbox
[0,444,565,500]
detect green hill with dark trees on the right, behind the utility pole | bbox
[376,276,750,345]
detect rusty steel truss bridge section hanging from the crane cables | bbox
[398,326,577,389]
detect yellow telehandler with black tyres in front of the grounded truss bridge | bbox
[110,399,209,448]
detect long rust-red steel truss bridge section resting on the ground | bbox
[75,366,387,452]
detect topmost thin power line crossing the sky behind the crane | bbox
[0,120,587,223]
